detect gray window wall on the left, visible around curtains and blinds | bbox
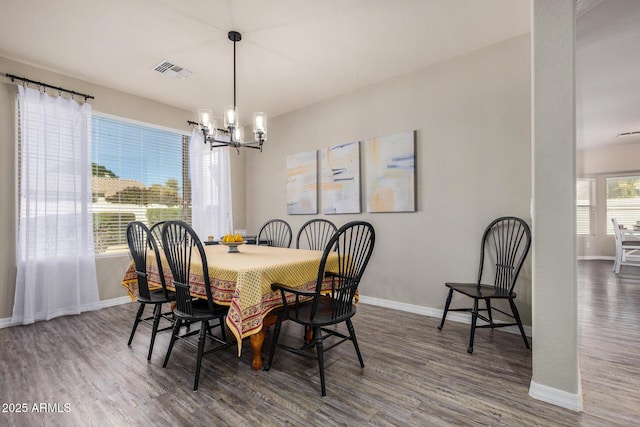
[0,57,245,319]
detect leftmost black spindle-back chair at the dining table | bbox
[126,221,176,360]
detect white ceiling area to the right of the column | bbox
[576,0,640,148]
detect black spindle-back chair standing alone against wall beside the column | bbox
[438,217,531,353]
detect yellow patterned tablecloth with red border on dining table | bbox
[122,245,337,355]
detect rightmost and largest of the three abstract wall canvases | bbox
[364,131,416,212]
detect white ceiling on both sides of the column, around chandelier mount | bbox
[0,0,640,150]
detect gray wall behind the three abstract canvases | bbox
[242,36,531,325]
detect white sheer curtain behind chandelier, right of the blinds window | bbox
[189,127,233,240]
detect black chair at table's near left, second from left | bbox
[162,221,233,391]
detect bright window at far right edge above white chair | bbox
[606,175,640,234]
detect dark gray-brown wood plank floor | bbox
[0,261,640,427]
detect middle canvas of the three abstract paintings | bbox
[320,142,360,214]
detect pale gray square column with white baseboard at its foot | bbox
[529,0,582,411]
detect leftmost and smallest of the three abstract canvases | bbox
[287,150,318,215]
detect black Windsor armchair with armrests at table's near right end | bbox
[265,221,375,396]
